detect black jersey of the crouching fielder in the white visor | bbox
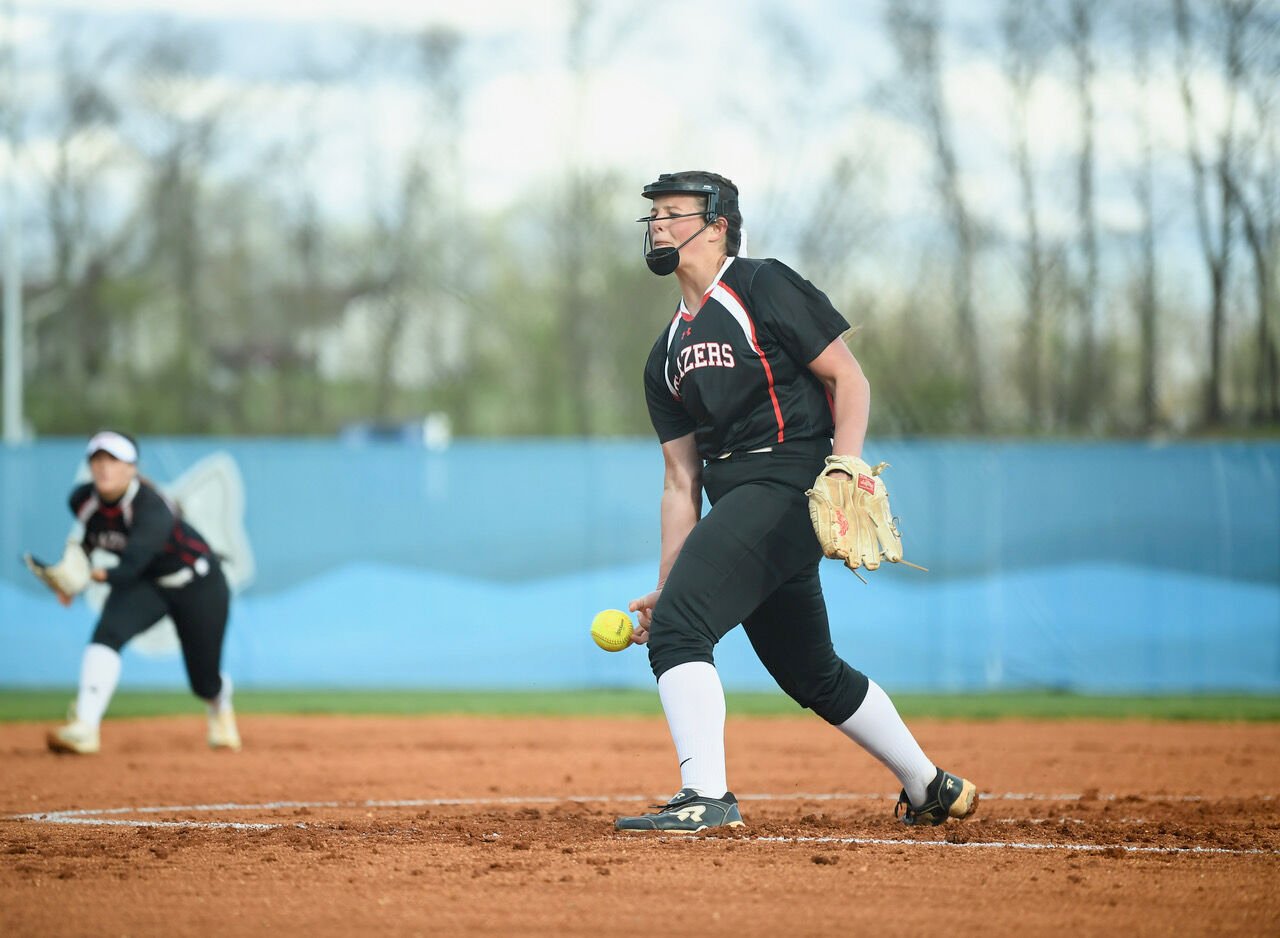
[70,479,215,586]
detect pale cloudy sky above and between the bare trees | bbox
[0,0,1254,263]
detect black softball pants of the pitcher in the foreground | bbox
[649,440,867,726]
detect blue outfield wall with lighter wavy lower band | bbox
[0,439,1280,694]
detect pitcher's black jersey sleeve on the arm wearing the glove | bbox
[749,261,849,365]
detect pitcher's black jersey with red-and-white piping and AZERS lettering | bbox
[644,257,849,459]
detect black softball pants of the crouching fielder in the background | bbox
[92,563,230,700]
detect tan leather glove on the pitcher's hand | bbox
[805,456,915,573]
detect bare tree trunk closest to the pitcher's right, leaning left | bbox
[887,0,988,433]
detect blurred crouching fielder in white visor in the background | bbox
[27,430,241,755]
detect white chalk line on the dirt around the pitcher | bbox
[9,792,1280,856]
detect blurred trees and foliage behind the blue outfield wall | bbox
[6,0,1280,436]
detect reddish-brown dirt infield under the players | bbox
[0,717,1280,938]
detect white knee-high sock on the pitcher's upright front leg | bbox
[658,662,728,799]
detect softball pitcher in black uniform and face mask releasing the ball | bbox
[617,171,978,832]
